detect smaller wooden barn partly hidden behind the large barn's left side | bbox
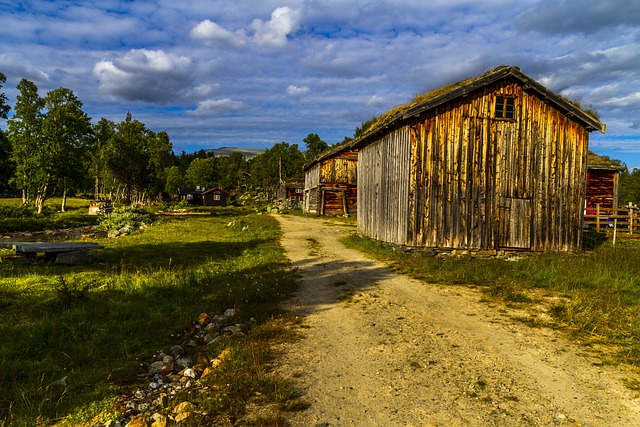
[303,144,358,215]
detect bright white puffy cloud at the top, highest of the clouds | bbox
[191,7,300,47]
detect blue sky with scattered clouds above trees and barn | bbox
[0,0,640,169]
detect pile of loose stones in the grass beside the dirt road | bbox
[91,309,253,427]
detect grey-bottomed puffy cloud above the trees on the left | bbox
[93,49,192,102]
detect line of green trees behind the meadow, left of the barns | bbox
[0,73,338,213]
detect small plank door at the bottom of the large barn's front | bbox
[500,197,531,249]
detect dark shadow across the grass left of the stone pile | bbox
[0,256,296,425]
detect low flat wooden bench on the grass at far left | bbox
[0,242,104,264]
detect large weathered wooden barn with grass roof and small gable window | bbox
[351,66,605,254]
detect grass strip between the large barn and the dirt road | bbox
[344,235,640,366]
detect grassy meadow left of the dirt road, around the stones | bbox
[0,207,296,426]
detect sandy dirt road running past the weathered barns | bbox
[277,215,640,427]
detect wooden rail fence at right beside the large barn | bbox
[584,204,640,237]
